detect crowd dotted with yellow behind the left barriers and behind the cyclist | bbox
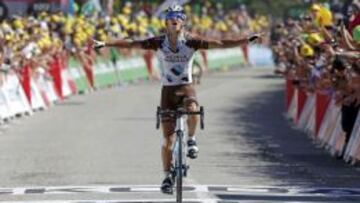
[0,1,269,84]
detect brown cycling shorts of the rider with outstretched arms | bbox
[160,84,198,122]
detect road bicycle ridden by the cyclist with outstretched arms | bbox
[156,106,205,203]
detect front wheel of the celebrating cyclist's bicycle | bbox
[175,131,183,203]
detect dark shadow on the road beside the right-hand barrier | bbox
[225,83,360,187]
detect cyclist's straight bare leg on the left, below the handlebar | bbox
[161,121,176,172]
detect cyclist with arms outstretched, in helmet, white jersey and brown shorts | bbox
[94,5,261,194]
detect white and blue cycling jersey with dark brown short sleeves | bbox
[142,34,208,86]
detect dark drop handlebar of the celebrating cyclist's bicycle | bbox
[156,106,205,130]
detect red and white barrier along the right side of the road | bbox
[285,79,360,164]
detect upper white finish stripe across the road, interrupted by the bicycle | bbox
[0,184,360,199]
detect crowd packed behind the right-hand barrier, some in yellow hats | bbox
[271,0,360,158]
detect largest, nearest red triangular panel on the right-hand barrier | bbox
[315,93,331,135]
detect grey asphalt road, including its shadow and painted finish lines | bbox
[0,68,360,203]
